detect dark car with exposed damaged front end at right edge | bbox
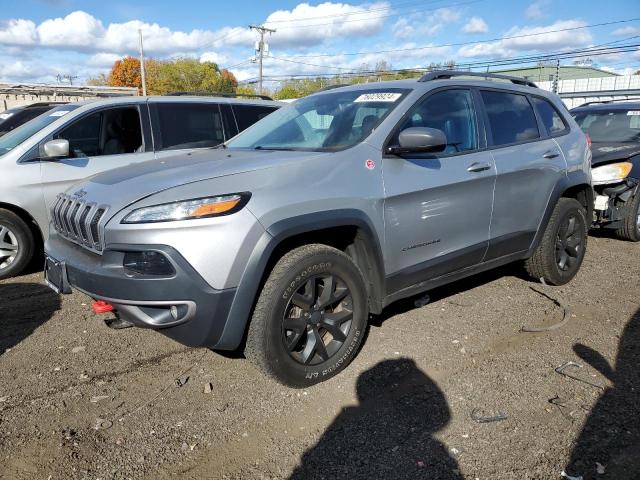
[571,101,640,242]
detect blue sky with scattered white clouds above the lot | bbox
[0,0,640,83]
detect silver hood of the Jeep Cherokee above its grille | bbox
[67,149,326,209]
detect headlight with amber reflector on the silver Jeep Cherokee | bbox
[122,193,251,223]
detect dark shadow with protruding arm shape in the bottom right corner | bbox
[566,310,640,480]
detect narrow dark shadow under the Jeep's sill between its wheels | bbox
[369,262,524,327]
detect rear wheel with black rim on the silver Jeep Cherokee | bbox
[525,198,588,285]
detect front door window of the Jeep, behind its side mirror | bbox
[393,89,478,154]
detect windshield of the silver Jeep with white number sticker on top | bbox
[226,88,409,152]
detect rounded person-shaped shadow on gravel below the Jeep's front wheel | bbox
[290,358,462,480]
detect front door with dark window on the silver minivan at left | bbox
[40,104,154,218]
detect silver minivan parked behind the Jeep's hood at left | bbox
[0,96,280,279]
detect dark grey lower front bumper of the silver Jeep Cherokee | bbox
[45,232,236,347]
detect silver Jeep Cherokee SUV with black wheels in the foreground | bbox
[45,71,593,387]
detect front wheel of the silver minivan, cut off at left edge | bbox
[0,208,35,280]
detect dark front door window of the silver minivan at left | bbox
[54,107,142,158]
